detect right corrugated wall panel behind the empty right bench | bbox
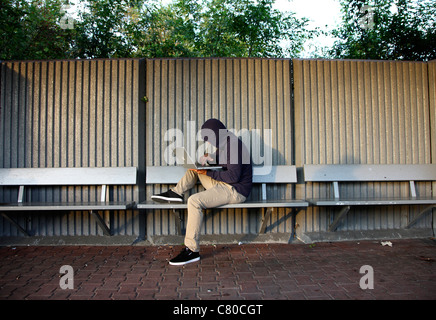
[293,60,434,232]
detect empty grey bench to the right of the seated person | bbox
[304,164,436,231]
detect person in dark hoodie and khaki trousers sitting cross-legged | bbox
[151,119,253,265]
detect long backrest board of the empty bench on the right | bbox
[304,164,436,182]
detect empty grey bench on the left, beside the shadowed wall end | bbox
[0,167,137,236]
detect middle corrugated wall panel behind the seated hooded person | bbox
[146,59,293,235]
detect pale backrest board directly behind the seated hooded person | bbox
[146,166,297,184]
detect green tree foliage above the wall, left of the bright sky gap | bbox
[0,0,315,59]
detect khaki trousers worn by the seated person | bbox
[172,170,246,252]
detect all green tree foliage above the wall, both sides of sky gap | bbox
[0,0,436,61]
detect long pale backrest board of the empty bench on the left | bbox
[0,167,137,186]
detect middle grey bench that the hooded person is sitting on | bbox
[136,166,309,234]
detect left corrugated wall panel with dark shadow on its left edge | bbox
[0,59,145,236]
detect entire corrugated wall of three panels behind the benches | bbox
[0,59,436,240]
